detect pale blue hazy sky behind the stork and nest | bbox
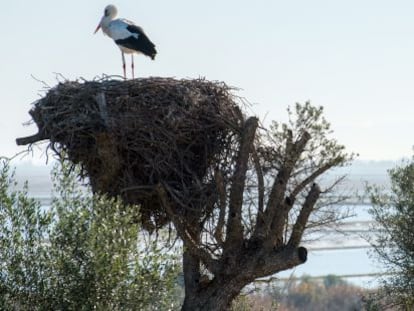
[0,0,414,160]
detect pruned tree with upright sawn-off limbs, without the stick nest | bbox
[162,103,352,310]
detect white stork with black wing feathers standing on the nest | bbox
[94,4,157,79]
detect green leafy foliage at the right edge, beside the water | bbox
[368,157,414,310]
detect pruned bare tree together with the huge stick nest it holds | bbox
[18,79,352,311]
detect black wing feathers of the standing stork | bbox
[115,25,157,59]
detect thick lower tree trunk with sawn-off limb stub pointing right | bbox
[181,246,307,311]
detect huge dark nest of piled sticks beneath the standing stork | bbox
[17,78,243,230]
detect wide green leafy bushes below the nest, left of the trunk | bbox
[0,160,179,310]
